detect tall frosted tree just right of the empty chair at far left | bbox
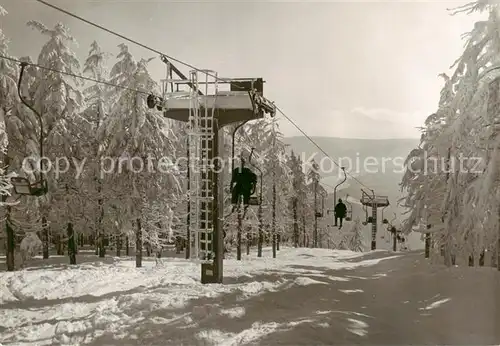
[24,21,83,258]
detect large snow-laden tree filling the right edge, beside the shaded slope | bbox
[403,1,500,265]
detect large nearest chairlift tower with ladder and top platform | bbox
[148,61,276,283]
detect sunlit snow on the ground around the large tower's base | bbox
[0,248,394,345]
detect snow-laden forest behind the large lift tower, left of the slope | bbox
[0,10,368,271]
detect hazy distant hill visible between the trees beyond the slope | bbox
[284,136,423,249]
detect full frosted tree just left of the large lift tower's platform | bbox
[99,45,182,266]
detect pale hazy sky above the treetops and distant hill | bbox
[0,0,483,139]
